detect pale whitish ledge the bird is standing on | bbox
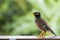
[0,36,60,40]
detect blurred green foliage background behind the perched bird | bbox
[0,0,60,36]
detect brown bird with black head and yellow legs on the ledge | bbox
[33,12,56,38]
